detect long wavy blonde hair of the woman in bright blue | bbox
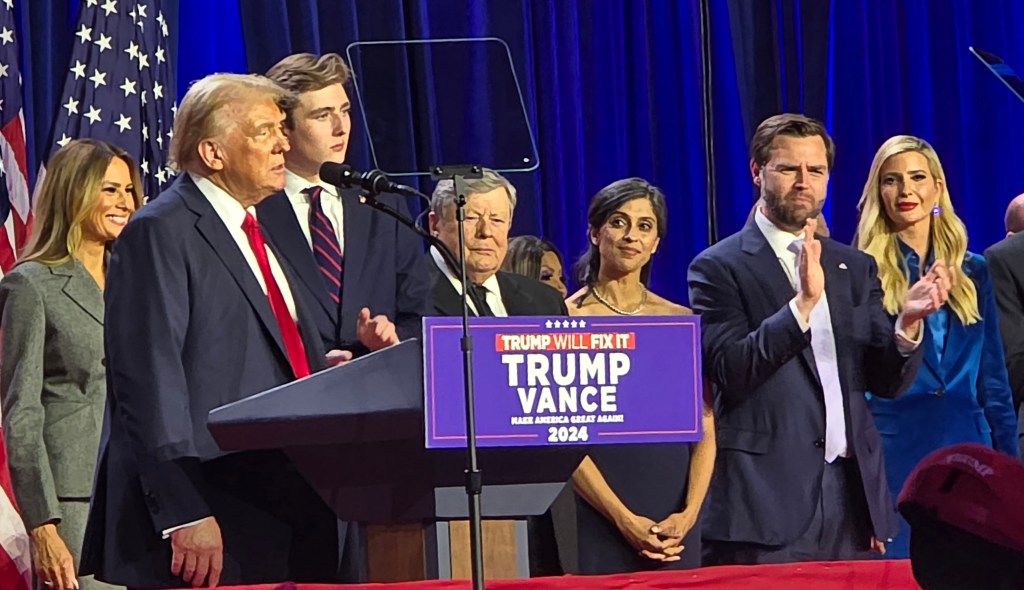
[853,135,981,326]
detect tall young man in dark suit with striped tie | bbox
[257,53,430,356]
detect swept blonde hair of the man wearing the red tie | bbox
[169,74,296,175]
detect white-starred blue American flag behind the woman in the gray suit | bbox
[51,0,177,198]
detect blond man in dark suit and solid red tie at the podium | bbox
[81,74,338,588]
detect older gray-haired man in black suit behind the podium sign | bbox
[427,169,568,318]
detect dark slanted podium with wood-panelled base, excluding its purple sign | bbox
[209,340,586,582]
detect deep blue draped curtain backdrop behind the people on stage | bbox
[18,0,1024,302]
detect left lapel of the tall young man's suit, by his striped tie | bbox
[257,193,338,318]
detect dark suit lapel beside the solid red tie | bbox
[182,176,288,360]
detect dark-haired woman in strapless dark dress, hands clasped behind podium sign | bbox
[566,178,715,575]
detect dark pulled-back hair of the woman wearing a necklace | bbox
[572,178,669,287]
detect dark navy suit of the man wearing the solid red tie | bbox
[81,174,334,588]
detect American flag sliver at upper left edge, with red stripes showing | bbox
[0,0,32,275]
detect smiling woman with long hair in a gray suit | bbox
[0,139,142,590]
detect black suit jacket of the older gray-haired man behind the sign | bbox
[424,252,569,315]
